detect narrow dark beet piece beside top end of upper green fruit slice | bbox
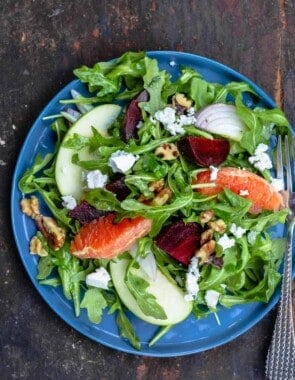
[122,91,148,142]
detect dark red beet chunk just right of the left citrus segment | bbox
[156,220,202,266]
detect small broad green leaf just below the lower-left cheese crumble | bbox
[81,288,107,323]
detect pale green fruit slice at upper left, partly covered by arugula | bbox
[55,104,121,200]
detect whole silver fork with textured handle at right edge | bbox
[265,136,295,380]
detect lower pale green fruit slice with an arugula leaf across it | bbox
[110,259,192,326]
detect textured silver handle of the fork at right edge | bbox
[266,222,295,380]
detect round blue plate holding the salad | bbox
[11,51,292,357]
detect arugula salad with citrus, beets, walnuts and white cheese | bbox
[19,52,290,350]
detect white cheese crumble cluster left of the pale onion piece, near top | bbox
[154,107,196,136]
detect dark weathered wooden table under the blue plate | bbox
[0,0,295,380]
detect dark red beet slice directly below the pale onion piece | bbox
[178,136,230,166]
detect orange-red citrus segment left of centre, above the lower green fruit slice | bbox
[71,214,152,259]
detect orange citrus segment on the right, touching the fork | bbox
[193,167,284,213]
